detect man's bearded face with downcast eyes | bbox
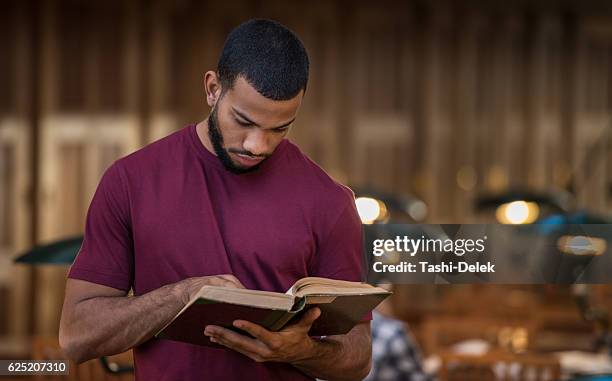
[208,77,303,173]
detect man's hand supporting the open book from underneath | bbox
[204,307,321,363]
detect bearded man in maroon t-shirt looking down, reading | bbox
[59,20,371,380]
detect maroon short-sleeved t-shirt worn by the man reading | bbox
[68,125,362,380]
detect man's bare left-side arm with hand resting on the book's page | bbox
[59,275,242,363]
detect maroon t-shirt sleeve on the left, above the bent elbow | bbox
[68,162,134,291]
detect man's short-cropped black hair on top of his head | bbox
[217,19,309,100]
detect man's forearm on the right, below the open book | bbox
[293,323,372,381]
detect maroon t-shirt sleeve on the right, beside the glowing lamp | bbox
[313,193,372,322]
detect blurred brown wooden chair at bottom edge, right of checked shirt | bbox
[439,352,561,381]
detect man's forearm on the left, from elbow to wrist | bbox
[60,284,185,362]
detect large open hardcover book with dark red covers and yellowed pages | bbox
[155,277,390,346]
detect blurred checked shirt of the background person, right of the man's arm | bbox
[365,313,432,381]
